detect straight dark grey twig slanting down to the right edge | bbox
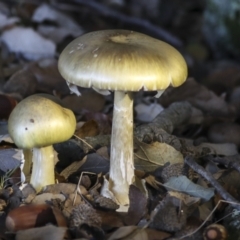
[185,156,240,211]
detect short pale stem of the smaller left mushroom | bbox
[30,145,55,192]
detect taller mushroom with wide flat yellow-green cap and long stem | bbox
[58,30,187,205]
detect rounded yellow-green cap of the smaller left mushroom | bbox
[8,94,76,149]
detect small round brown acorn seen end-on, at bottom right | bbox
[203,224,227,240]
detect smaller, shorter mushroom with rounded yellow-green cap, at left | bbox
[8,94,76,192]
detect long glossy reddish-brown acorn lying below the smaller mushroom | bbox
[6,204,67,232]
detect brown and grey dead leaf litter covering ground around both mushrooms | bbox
[0,0,240,240]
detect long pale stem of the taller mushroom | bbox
[109,91,134,205]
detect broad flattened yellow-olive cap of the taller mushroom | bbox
[58,30,187,91]
